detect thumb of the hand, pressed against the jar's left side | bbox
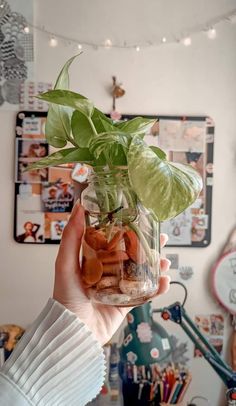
[57,203,84,271]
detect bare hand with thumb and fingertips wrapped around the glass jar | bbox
[53,203,170,345]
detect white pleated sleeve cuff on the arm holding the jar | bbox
[0,299,105,406]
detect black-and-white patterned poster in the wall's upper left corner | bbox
[0,0,34,110]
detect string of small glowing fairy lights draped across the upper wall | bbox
[0,0,236,52]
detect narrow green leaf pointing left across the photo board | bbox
[27,148,94,171]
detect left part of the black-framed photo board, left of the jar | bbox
[14,111,82,244]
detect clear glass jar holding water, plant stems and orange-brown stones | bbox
[81,168,160,306]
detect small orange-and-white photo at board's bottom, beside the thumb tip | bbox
[44,213,70,241]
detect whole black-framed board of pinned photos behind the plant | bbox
[14,111,214,247]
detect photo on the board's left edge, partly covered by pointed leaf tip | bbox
[15,139,48,183]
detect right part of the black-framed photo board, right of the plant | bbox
[123,116,215,247]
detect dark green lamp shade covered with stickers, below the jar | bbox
[120,302,171,366]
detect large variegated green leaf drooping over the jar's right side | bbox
[127,137,202,221]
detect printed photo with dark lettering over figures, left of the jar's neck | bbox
[42,182,74,213]
